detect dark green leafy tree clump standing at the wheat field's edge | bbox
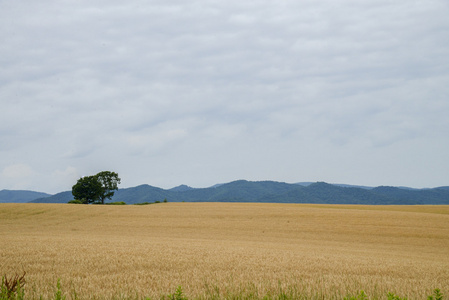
[72,171,120,204]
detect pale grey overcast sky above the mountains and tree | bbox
[0,0,449,194]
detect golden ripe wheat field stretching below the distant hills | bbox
[0,203,449,299]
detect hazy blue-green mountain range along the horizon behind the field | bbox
[0,180,449,205]
